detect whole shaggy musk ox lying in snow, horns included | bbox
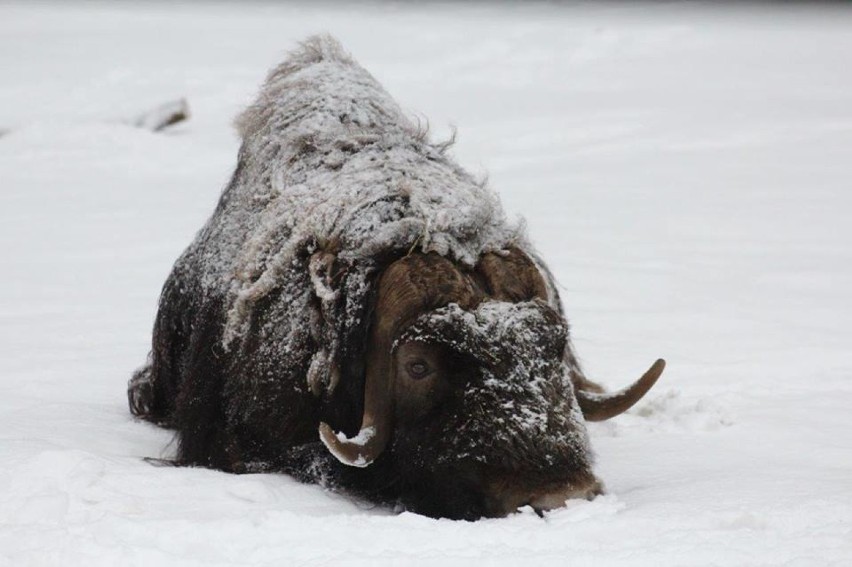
[128,37,663,519]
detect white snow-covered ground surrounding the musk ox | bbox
[0,3,852,567]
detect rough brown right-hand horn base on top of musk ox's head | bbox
[476,248,548,303]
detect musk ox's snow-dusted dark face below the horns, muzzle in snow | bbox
[391,299,598,518]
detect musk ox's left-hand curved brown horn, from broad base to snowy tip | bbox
[319,253,481,467]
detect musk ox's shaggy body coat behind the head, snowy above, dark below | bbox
[129,37,600,517]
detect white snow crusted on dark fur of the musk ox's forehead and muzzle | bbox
[396,300,591,468]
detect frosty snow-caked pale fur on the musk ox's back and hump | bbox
[177,36,525,355]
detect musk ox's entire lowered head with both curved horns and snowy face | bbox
[320,249,662,519]
